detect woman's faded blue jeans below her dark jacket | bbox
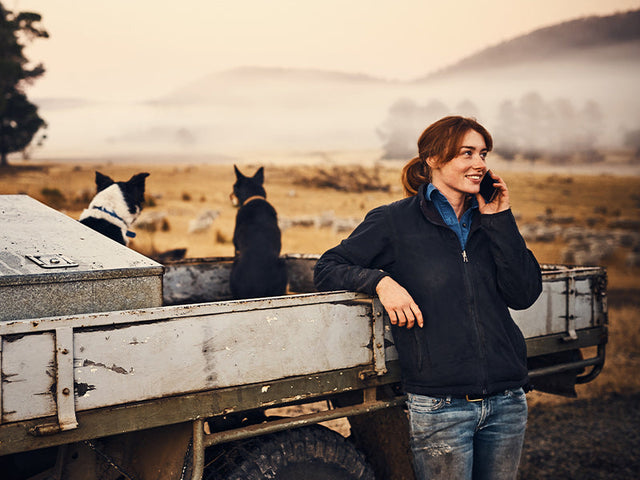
[407,388,527,480]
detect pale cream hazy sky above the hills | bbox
[8,0,640,100]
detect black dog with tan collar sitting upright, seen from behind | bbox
[230,165,287,299]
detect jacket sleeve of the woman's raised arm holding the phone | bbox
[481,210,542,310]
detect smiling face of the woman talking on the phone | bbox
[428,130,487,201]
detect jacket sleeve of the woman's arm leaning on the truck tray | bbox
[314,206,393,295]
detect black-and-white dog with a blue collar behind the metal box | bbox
[80,172,149,245]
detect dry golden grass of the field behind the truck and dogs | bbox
[0,163,640,403]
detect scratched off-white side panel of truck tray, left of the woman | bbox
[0,293,381,421]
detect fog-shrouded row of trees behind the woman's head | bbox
[377,92,628,162]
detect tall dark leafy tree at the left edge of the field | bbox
[0,3,49,166]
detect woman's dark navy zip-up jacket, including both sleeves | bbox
[314,185,542,396]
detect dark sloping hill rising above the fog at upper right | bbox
[417,10,640,81]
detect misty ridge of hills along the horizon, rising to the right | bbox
[154,10,640,112]
